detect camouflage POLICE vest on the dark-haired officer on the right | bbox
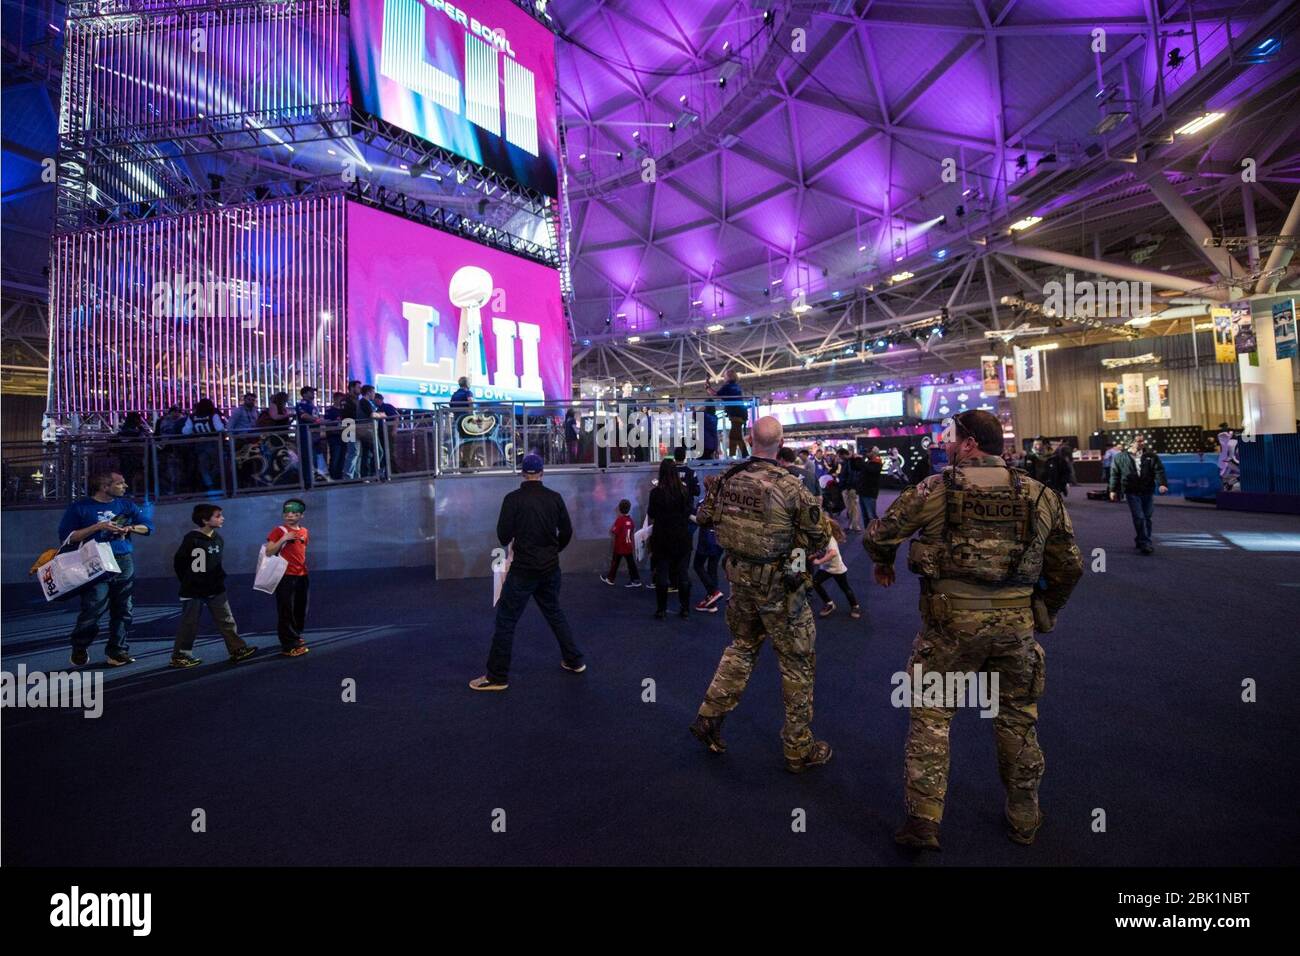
[907,467,1043,587]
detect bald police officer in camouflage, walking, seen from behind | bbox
[690,416,831,774]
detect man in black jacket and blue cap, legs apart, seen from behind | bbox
[469,455,586,691]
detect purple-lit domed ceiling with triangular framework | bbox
[551,0,1300,390]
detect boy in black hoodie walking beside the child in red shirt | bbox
[170,505,257,667]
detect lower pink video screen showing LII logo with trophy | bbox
[347,203,571,408]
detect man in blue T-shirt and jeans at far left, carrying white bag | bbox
[59,471,153,667]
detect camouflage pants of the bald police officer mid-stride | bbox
[699,562,816,760]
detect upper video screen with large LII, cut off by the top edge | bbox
[350,0,559,196]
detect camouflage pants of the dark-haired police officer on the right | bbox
[904,607,1047,829]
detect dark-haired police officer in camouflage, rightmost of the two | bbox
[862,411,1083,849]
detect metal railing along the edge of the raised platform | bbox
[0,397,757,507]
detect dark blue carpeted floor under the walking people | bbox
[3,496,1300,866]
